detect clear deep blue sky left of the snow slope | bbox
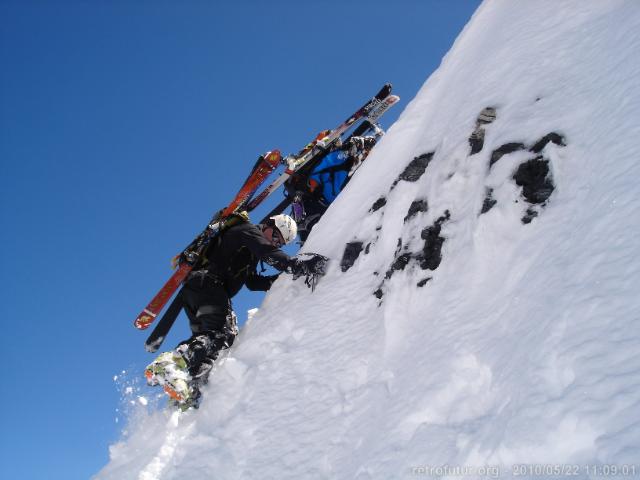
[0,0,479,480]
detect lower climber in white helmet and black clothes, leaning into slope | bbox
[145,215,326,406]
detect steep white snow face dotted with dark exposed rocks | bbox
[97,0,640,479]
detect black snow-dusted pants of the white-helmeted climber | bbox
[176,275,238,383]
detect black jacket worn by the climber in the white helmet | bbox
[199,223,295,298]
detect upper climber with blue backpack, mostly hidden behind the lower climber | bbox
[285,124,384,243]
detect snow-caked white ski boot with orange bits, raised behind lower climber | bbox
[144,351,194,408]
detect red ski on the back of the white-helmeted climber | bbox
[133,150,282,330]
